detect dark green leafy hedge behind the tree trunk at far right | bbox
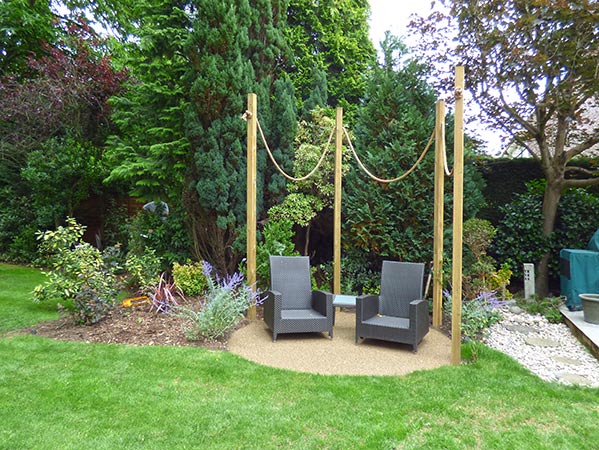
[493,183,599,278]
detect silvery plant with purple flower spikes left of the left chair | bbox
[178,261,258,340]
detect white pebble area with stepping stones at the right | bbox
[484,306,599,387]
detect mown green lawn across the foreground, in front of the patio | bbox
[0,262,599,450]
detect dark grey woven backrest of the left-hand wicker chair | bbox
[270,255,312,309]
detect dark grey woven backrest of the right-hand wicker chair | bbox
[379,261,424,317]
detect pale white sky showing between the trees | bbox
[370,0,502,155]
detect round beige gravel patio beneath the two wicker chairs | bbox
[228,312,451,375]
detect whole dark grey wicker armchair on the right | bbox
[356,261,429,352]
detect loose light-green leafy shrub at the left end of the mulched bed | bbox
[33,218,117,324]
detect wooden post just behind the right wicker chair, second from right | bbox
[433,100,445,328]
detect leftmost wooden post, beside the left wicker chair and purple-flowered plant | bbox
[247,94,258,320]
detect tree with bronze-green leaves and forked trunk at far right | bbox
[419,0,599,295]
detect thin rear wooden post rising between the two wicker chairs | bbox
[333,108,343,294]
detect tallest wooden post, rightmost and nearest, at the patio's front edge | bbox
[451,66,464,365]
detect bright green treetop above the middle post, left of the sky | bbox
[286,0,376,117]
